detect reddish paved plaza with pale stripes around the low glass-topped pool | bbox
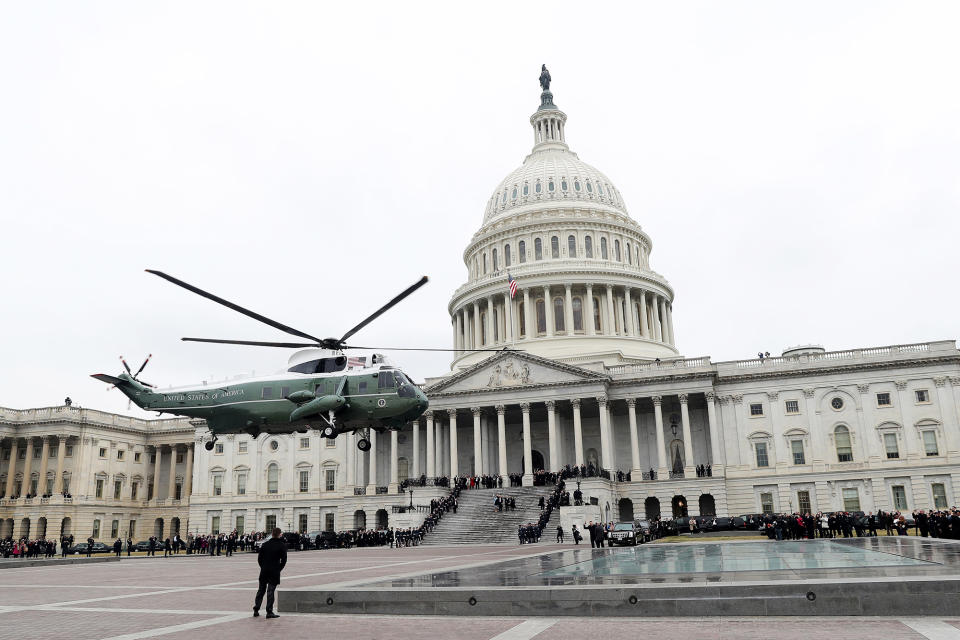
[0,543,960,640]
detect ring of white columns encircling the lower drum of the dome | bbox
[452,284,675,349]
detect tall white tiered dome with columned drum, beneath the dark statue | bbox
[449,70,678,370]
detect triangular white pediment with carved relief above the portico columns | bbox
[424,352,607,396]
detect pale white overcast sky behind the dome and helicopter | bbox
[0,2,960,416]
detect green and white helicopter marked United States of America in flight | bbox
[92,269,480,451]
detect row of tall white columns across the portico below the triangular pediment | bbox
[358,393,721,492]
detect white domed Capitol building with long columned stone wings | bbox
[0,77,960,541]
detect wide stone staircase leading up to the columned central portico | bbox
[422,485,557,545]
